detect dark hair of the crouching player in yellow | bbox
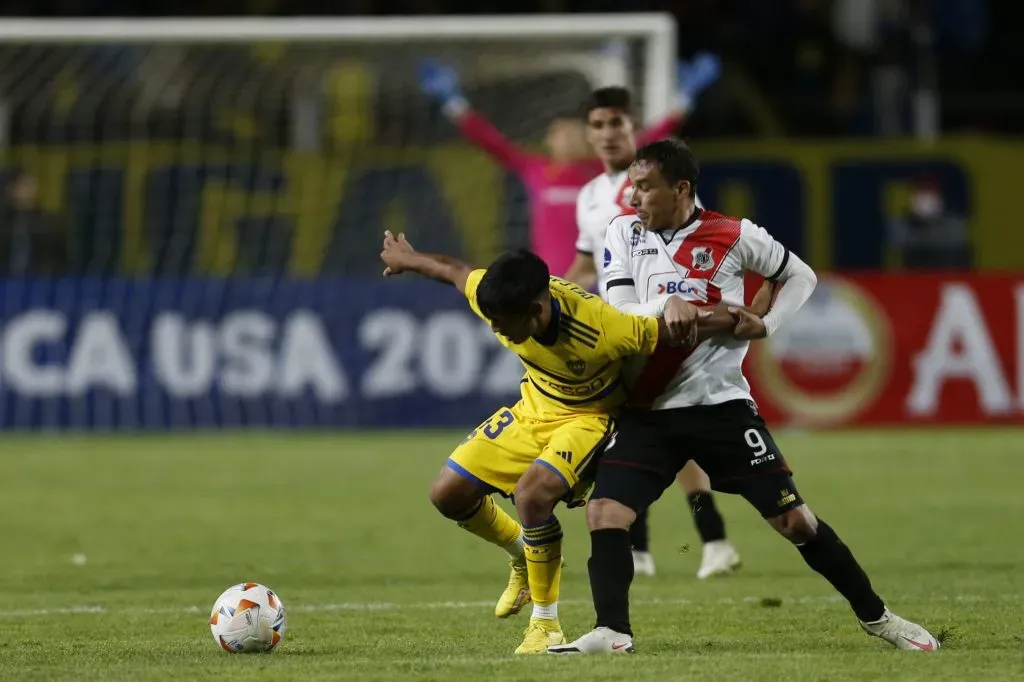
[476,249,551,318]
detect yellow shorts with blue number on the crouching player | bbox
[447,404,614,500]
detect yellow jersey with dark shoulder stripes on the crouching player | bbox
[466,269,657,419]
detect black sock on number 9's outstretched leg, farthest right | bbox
[797,518,886,623]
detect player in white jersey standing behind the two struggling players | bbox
[565,82,740,579]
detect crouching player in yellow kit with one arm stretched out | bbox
[381,231,749,653]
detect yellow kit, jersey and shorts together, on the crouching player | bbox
[449,269,658,498]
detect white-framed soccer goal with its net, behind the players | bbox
[0,14,675,428]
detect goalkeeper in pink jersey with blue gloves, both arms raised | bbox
[419,55,720,275]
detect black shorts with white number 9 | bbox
[591,400,803,518]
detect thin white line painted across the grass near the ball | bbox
[0,594,1007,619]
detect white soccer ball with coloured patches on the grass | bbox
[210,583,288,653]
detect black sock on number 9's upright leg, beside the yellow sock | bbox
[587,528,633,636]
